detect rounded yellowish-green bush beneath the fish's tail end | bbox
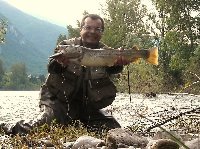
[115,61,163,93]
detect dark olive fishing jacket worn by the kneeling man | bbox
[40,38,123,115]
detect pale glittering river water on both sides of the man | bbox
[0,91,200,133]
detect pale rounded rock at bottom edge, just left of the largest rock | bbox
[72,135,105,149]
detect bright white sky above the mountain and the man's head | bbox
[6,0,106,27]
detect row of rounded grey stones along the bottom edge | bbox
[0,128,200,149]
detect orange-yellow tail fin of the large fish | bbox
[147,47,158,65]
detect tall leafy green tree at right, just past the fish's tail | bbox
[151,0,200,89]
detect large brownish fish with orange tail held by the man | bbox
[49,45,158,67]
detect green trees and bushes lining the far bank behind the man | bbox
[0,0,200,94]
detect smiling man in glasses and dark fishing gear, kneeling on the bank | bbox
[0,14,128,134]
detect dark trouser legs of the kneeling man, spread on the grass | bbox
[5,105,120,135]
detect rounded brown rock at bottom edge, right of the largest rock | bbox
[146,139,179,149]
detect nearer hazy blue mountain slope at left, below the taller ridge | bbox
[0,21,47,74]
